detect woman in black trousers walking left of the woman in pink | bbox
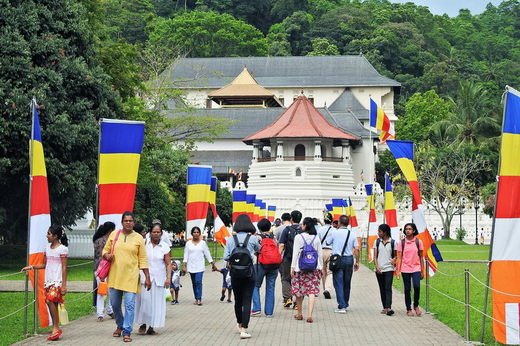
[374,223,397,316]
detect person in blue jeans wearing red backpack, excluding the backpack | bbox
[251,219,278,317]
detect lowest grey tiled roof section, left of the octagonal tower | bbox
[191,151,253,174]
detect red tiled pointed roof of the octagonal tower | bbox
[242,95,359,142]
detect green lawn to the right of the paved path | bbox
[365,240,496,345]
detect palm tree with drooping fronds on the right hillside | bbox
[431,81,500,145]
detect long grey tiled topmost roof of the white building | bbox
[169,55,401,88]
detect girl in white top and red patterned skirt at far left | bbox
[22,225,69,341]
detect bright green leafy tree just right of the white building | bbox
[396,90,452,142]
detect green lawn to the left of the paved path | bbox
[0,292,93,345]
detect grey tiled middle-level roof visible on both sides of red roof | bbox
[166,107,369,140]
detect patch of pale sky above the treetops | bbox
[390,0,502,17]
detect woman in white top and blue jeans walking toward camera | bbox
[182,226,217,306]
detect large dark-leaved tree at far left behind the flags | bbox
[0,0,120,243]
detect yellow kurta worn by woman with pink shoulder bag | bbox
[103,231,148,293]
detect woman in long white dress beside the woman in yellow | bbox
[136,223,171,335]
